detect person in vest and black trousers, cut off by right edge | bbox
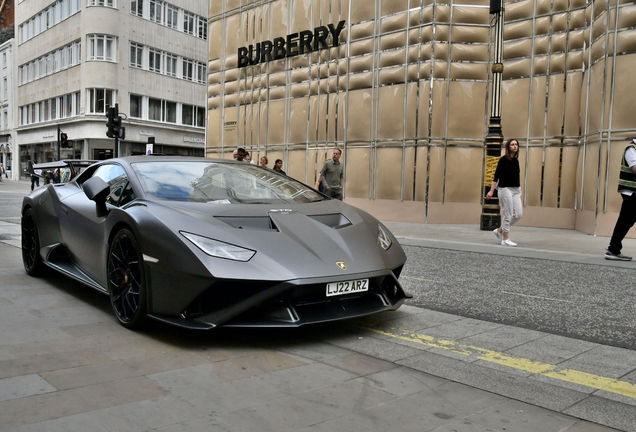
[605,138,636,261]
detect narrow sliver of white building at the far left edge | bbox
[0,39,18,179]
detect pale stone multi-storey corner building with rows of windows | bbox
[14,0,208,179]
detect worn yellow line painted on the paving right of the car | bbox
[362,327,636,399]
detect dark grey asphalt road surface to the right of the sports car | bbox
[400,246,636,349]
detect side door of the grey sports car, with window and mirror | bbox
[60,163,134,285]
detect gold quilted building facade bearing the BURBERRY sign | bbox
[206,0,636,235]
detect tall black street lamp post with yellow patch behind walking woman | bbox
[479,0,504,231]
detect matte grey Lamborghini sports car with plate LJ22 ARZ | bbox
[22,156,407,329]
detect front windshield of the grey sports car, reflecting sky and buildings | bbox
[132,161,324,204]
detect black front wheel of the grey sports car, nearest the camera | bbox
[106,229,147,329]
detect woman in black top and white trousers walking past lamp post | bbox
[486,138,522,246]
